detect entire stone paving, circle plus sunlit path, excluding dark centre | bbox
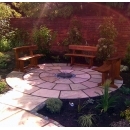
[0,63,123,127]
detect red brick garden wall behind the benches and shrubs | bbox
[10,16,130,57]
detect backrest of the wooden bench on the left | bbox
[13,45,37,59]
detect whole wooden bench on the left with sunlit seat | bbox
[13,45,44,72]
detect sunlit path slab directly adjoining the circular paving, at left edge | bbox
[0,90,46,110]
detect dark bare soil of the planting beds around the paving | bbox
[0,52,130,127]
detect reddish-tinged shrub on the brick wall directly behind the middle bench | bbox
[63,19,83,46]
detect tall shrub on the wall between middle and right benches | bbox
[97,17,118,61]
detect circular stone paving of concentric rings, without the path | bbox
[6,63,123,99]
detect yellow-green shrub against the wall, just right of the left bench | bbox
[33,26,56,56]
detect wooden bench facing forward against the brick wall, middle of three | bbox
[65,45,97,68]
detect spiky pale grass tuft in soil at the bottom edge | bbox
[78,114,94,127]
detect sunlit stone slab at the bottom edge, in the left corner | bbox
[0,110,49,127]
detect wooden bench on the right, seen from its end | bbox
[93,57,122,88]
